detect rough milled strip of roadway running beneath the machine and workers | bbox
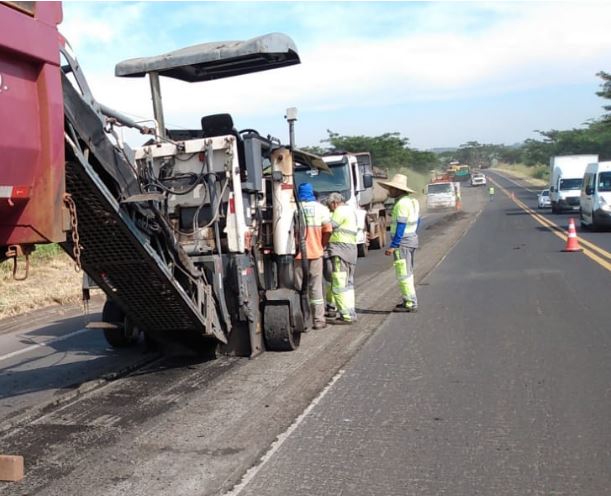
[0,192,481,496]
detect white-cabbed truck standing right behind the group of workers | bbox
[295,152,389,257]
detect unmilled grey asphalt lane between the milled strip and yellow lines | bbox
[230,176,611,496]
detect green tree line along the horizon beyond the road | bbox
[305,71,611,172]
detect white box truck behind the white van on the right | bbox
[549,155,598,214]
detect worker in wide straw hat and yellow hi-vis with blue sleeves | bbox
[380,174,420,312]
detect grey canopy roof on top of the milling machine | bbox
[115,33,300,83]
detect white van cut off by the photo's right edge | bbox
[580,162,611,229]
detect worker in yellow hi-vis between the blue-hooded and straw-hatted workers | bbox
[327,193,357,324]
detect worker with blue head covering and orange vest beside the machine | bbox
[295,183,332,329]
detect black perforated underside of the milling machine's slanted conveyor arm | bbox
[66,153,211,337]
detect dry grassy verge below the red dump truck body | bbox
[0,244,82,319]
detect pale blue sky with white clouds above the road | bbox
[60,2,611,149]
